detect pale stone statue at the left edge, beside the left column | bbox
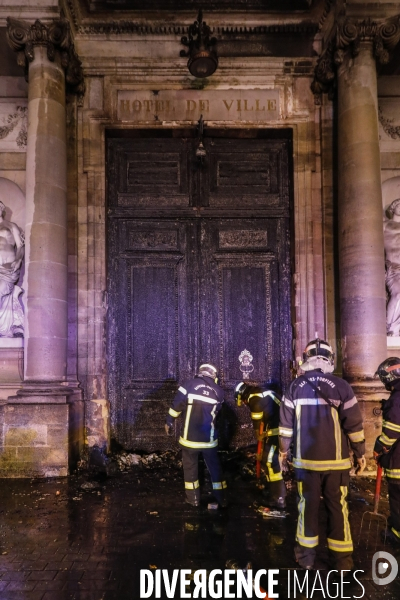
[0,201,25,337]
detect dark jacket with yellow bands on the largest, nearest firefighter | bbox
[279,369,365,471]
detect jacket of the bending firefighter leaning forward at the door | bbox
[247,387,281,437]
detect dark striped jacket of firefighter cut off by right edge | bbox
[374,381,400,484]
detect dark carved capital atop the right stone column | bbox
[311,15,400,104]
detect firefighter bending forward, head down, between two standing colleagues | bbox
[235,381,286,510]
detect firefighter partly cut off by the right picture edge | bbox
[374,356,400,545]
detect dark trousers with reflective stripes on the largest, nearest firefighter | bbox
[295,469,353,571]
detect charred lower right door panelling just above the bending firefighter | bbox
[200,219,287,387]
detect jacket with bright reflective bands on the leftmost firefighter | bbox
[166,375,224,449]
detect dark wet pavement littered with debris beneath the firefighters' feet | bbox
[0,452,400,600]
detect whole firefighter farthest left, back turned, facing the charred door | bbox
[165,364,227,507]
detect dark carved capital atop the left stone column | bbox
[7,18,85,96]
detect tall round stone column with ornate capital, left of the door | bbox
[8,19,80,383]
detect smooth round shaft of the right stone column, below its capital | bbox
[337,40,386,380]
